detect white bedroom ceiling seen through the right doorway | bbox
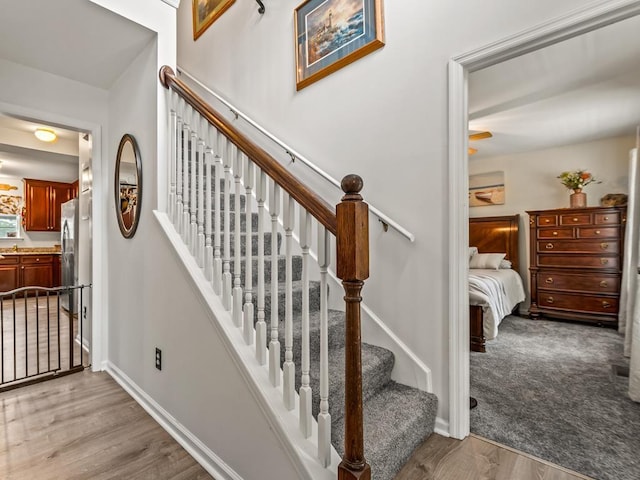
[469,16,640,161]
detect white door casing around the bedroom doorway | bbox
[449,0,640,438]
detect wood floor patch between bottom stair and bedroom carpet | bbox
[395,434,591,480]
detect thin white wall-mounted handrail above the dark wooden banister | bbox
[177,67,415,242]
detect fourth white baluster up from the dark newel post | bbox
[269,182,281,387]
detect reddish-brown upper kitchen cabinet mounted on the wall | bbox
[24,178,74,232]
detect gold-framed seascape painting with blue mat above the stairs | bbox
[294,0,384,90]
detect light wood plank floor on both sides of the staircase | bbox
[0,370,589,480]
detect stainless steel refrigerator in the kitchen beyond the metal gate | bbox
[60,198,79,315]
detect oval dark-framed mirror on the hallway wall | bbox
[115,133,142,238]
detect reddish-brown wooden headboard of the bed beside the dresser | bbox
[469,215,520,272]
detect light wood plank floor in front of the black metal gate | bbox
[0,371,212,480]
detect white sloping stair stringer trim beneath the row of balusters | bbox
[153,210,341,480]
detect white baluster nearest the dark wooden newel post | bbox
[318,225,331,467]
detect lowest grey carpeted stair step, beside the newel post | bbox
[331,381,438,480]
